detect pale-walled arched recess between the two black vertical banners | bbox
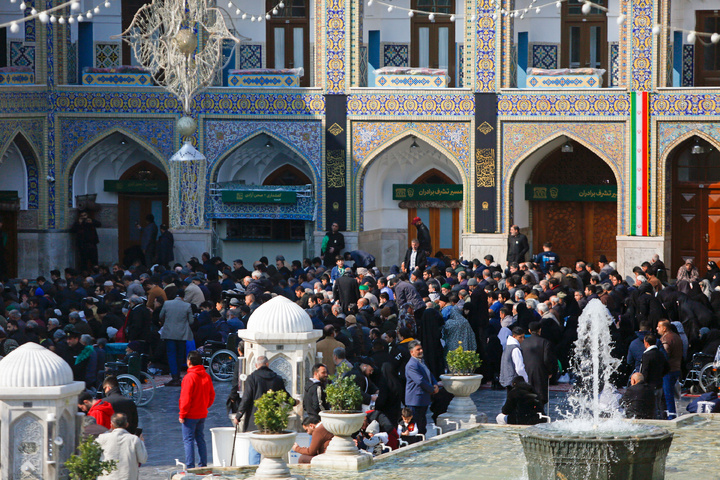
[357,135,464,268]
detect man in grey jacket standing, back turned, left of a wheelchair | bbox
[160,290,195,387]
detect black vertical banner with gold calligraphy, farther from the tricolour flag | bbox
[325,95,347,231]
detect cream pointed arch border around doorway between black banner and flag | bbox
[498,130,625,232]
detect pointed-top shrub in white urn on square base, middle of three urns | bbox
[312,364,372,470]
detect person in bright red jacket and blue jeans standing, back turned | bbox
[180,351,215,468]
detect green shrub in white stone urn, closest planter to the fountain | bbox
[440,342,483,425]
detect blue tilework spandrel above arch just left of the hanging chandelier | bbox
[59,117,176,172]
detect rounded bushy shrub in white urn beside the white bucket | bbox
[250,390,296,479]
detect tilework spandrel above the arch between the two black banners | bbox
[352,122,471,175]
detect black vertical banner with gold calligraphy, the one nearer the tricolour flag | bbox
[472,93,497,233]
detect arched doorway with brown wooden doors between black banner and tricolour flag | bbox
[525,141,617,266]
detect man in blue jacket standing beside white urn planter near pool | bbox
[405,340,440,435]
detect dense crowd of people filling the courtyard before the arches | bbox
[0,218,720,474]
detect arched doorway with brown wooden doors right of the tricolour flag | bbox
[668,136,720,272]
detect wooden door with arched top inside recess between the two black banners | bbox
[408,168,460,258]
